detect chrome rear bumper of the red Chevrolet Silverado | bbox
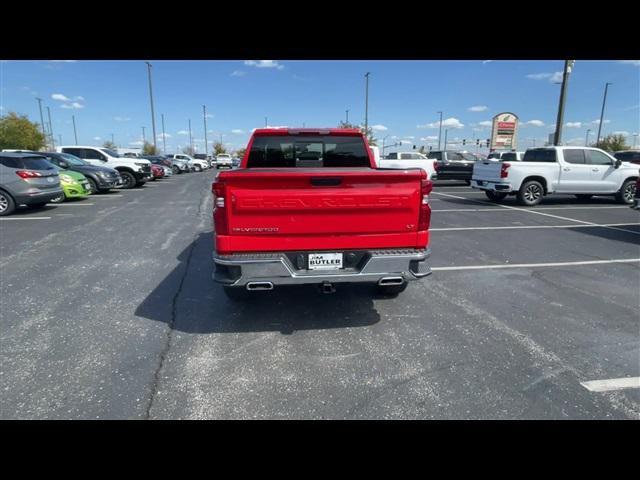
[212,248,431,287]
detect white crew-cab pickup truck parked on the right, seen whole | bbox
[471,147,638,206]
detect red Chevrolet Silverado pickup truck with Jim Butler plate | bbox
[212,128,432,299]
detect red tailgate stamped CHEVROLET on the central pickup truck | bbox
[216,168,427,252]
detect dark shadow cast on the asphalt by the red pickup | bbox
[135,232,380,334]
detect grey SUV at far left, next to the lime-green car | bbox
[0,152,63,216]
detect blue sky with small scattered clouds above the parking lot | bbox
[0,60,640,152]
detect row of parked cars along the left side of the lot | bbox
[0,145,234,216]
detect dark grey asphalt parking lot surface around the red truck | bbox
[0,171,640,419]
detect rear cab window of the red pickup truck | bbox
[246,135,371,168]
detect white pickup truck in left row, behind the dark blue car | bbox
[56,145,152,188]
